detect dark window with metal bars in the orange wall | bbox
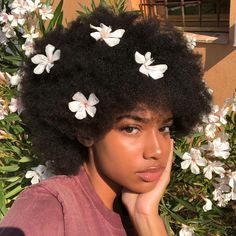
[140,0,230,32]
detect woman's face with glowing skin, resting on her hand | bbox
[86,109,173,193]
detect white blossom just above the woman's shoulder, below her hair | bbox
[25,163,53,184]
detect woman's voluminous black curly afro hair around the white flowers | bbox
[22,7,211,174]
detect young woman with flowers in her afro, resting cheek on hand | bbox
[0,8,211,236]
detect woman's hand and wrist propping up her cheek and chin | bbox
[122,140,173,236]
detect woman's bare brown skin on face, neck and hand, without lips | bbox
[79,108,173,236]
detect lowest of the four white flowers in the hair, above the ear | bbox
[68,92,99,120]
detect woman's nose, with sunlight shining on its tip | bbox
[143,130,162,159]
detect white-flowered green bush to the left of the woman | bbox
[0,0,63,218]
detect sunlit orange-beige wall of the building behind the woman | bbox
[55,0,236,105]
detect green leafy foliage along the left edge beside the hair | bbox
[0,0,63,219]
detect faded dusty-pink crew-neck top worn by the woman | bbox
[0,169,135,236]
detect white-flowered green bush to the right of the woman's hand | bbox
[161,89,236,236]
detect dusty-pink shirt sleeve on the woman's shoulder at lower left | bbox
[0,186,64,236]
